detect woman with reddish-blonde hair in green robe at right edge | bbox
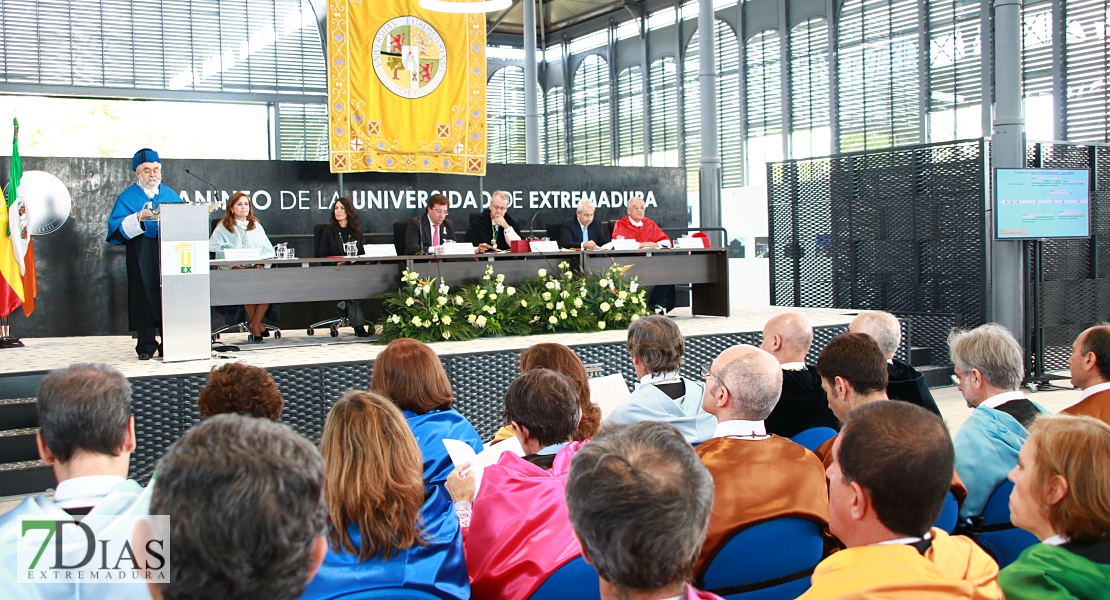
[998,415,1110,600]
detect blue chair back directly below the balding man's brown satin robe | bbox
[699,517,825,600]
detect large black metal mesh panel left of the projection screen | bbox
[767,140,986,326]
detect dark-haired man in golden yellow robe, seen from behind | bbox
[801,403,1002,600]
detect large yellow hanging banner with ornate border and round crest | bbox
[327,0,486,175]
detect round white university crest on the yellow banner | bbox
[371,17,447,99]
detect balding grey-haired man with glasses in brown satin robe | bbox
[694,345,829,578]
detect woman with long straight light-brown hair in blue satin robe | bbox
[301,391,471,599]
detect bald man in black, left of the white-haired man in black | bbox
[759,313,839,437]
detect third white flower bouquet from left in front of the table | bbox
[519,261,597,333]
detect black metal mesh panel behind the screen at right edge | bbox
[1026,143,1110,374]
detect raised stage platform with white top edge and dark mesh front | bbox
[0,306,892,496]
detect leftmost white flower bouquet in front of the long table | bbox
[380,271,477,343]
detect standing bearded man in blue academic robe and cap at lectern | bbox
[107,148,183,360]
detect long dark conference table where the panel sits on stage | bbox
[209,248,728,316]
